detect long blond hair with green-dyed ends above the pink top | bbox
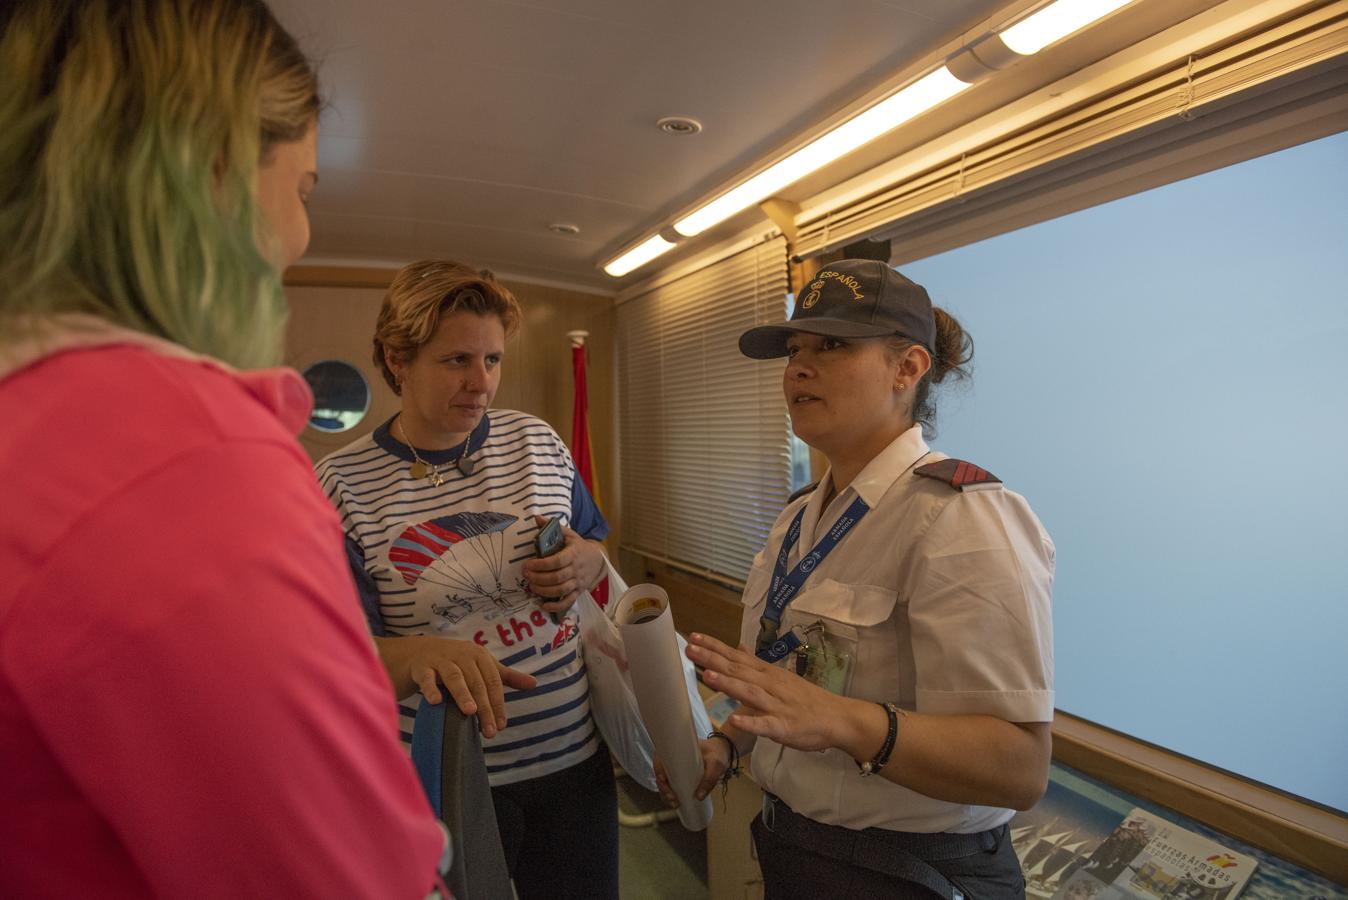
[0,0,319,366]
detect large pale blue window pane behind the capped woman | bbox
[900,133,1348,810]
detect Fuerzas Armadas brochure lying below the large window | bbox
[1053,810,1258,900]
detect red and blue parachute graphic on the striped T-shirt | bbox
[388,512,528,622]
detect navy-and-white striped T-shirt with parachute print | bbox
[318,410,608,785]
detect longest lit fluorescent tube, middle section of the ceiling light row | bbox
[674,66,969,237]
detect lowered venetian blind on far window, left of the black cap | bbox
[617,238,791,582]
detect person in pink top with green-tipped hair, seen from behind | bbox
[0,0,525,899]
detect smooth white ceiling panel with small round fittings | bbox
[271,0,1211,291]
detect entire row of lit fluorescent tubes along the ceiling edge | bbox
[604,0,1134,278]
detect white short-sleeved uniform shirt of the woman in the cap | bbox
[740,426,1054,833]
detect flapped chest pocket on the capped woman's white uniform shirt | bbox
[783,578,899,697]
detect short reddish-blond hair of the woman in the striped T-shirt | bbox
[373,260,522,396]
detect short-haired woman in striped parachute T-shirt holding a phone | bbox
[318,261,617,900]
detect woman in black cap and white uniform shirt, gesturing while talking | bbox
[667,254,1054,900]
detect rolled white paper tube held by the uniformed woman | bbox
[613,585,712,831]
